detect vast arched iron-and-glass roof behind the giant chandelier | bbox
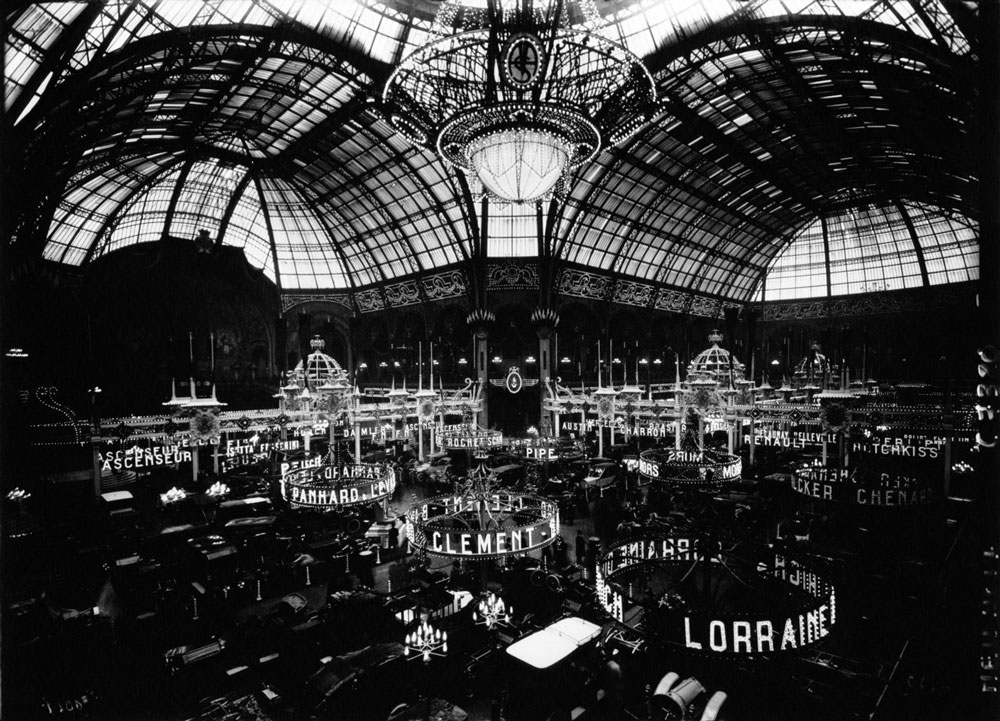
[5,0,978,302]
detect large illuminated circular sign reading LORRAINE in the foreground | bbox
[594,536,837,659]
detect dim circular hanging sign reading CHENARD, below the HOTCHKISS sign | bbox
[791,465,934,508]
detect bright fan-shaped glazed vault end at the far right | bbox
[754,203,979,301]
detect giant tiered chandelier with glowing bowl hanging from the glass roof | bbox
[382,0,656,203]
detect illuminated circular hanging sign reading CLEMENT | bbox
[406,490,559,559]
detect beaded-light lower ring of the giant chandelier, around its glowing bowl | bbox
[437,102,601,171]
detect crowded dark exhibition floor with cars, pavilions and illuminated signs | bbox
[5,334,995,720]
